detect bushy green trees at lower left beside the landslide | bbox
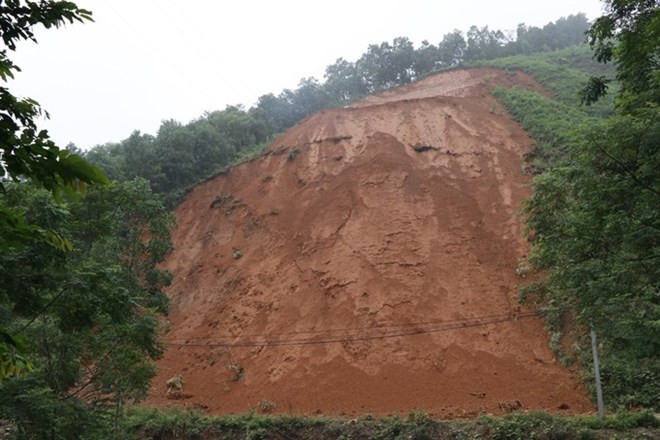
[0,180,173,438]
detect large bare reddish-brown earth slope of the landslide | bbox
[150,69,592,417]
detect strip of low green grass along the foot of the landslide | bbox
[116,407,660,440]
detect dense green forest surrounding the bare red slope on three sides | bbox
[0,0,660,438]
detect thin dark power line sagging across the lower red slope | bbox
[166,312,541,348]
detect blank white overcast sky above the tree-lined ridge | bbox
[9,0,602,149]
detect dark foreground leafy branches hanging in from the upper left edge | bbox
[0,0,108,381]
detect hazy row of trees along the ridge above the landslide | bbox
[85,14,594,206]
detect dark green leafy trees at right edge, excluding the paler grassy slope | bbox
[527,0,660,409]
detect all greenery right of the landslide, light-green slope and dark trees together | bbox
[493,2,660,409]
